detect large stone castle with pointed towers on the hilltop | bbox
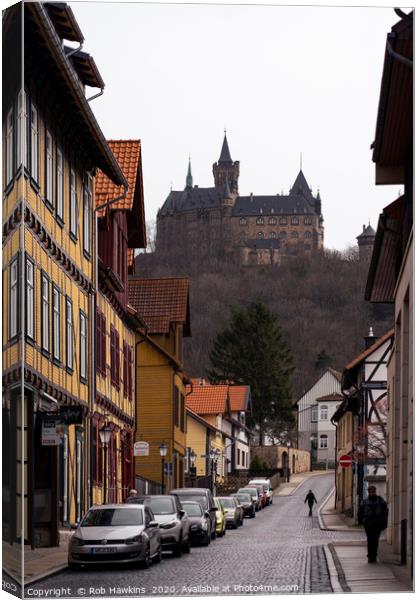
[156,134,324,264]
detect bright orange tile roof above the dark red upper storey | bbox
[95,140,140,216]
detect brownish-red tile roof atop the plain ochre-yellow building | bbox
[128,277,190,335]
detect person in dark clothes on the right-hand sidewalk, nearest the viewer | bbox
[358,485,388,563]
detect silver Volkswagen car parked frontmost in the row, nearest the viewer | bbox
[68,504,162,570]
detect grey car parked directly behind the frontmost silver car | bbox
[126,494,190,556]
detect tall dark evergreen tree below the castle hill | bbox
[207,301,294,446]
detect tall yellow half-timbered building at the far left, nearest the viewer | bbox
[3,3,125,548]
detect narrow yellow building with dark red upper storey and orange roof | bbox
[91,140,146,504]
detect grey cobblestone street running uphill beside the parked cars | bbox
[25,474,360,597]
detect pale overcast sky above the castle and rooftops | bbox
[69,2,406,249]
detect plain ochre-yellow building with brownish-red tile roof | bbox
[129,277,190,492]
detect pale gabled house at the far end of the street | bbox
[296,367,342,466]
